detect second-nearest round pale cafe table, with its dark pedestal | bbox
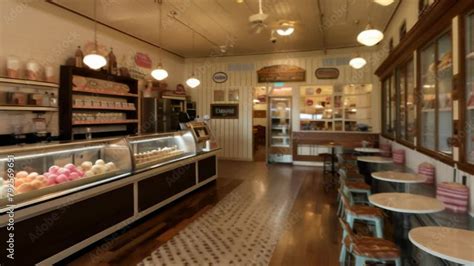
[369,192,445,239]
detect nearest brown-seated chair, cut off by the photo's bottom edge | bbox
[339,218,401,266]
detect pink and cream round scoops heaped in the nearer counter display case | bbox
[0,159,118,198]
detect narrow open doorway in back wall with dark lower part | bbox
[252,87,268,162]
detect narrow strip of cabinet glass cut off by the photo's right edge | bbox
[465,12,474,164]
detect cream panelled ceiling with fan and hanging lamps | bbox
[49,0,401,57]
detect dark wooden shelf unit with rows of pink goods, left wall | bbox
[59,66,140,140]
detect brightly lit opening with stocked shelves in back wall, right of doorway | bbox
[300,84,372,131]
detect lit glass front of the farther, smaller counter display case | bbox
[129,131,196,171]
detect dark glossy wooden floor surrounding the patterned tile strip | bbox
[65,161,340,265]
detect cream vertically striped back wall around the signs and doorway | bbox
[186,49,382,160]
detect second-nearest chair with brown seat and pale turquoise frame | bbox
[341,191,383,238]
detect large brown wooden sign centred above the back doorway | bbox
[257,65,306,83]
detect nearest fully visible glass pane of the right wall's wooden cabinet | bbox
[420,32,453,155]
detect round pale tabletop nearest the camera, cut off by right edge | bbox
[408,226,474,265]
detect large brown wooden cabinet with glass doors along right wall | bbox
[376,0,474,168]
